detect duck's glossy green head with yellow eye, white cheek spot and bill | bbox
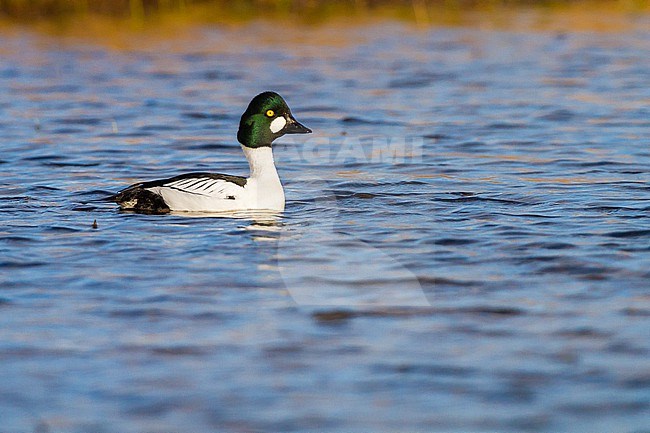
[237,92,311,148]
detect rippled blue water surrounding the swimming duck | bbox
[0,23,650,433]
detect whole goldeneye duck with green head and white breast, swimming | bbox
[113,92,311,213]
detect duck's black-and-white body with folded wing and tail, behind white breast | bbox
[114,173,246,213]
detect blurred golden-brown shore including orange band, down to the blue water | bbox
[0,0,650,33]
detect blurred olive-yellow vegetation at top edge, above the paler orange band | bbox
[0,0,650,23]
